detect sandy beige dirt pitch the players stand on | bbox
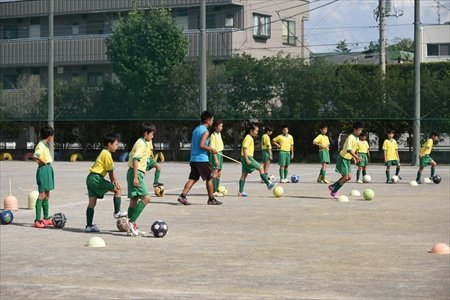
[0,161,450,299]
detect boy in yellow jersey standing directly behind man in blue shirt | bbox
[209,119,224,197]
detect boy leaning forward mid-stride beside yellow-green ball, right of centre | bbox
[328,122,364,199]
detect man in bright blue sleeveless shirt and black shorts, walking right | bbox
[178,110,222,205]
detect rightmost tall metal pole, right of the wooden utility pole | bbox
[411,0,422,166]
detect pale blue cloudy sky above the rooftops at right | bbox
[306,0,450,53]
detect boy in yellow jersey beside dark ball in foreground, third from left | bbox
[127,122,156,236]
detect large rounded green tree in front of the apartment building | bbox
[106,7,188,117]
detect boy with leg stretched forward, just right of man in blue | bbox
[238,124,275,197]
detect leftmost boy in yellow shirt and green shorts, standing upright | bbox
[33,125,55,228]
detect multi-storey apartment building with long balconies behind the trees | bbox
[0,0,309,92]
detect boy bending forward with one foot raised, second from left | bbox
[85,133,127,232]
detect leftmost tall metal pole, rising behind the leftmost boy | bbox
[47,0,55,157]
